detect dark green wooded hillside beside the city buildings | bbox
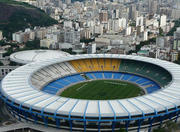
[0,0,58,39]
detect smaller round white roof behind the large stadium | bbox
[10,50,70,64]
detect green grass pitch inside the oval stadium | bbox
[61,80,144,100]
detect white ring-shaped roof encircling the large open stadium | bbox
[2,54,180,117]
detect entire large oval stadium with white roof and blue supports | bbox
[1,54,180,131]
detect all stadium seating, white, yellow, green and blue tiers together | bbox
[37,58,171,94]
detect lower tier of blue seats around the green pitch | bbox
[42,71,160,94]
